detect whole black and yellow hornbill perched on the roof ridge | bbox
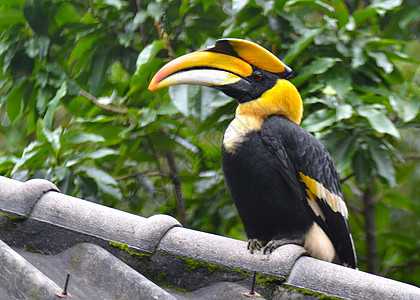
[149,39,357,268]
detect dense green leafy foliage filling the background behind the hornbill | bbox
[0,0,420,284]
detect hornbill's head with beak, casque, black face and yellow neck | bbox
[149,39,303,124]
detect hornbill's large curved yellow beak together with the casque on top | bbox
[149,39,291,91]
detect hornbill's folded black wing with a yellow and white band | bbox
[261,116,357,268]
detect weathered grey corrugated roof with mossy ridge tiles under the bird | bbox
[0,177,420,299]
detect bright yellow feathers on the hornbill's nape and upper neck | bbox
[236,79,303,124]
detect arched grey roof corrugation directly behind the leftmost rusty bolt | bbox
[18,243,176,300]
